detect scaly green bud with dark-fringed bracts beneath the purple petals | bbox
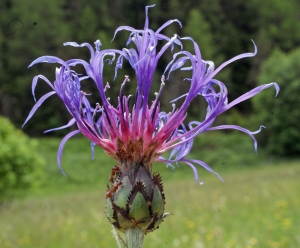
[106,162,167,233]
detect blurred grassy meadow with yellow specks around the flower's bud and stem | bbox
[0,139,300,248]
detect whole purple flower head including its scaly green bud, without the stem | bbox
[24,6,279,233]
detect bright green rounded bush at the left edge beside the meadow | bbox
[0,116,44,203]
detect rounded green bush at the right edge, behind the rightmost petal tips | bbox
[253,49,300,156]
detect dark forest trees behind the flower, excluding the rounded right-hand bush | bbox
[0,0,300,147]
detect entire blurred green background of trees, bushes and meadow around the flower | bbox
[0,0,300,248]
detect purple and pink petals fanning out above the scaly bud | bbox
[24,6,279,181]
